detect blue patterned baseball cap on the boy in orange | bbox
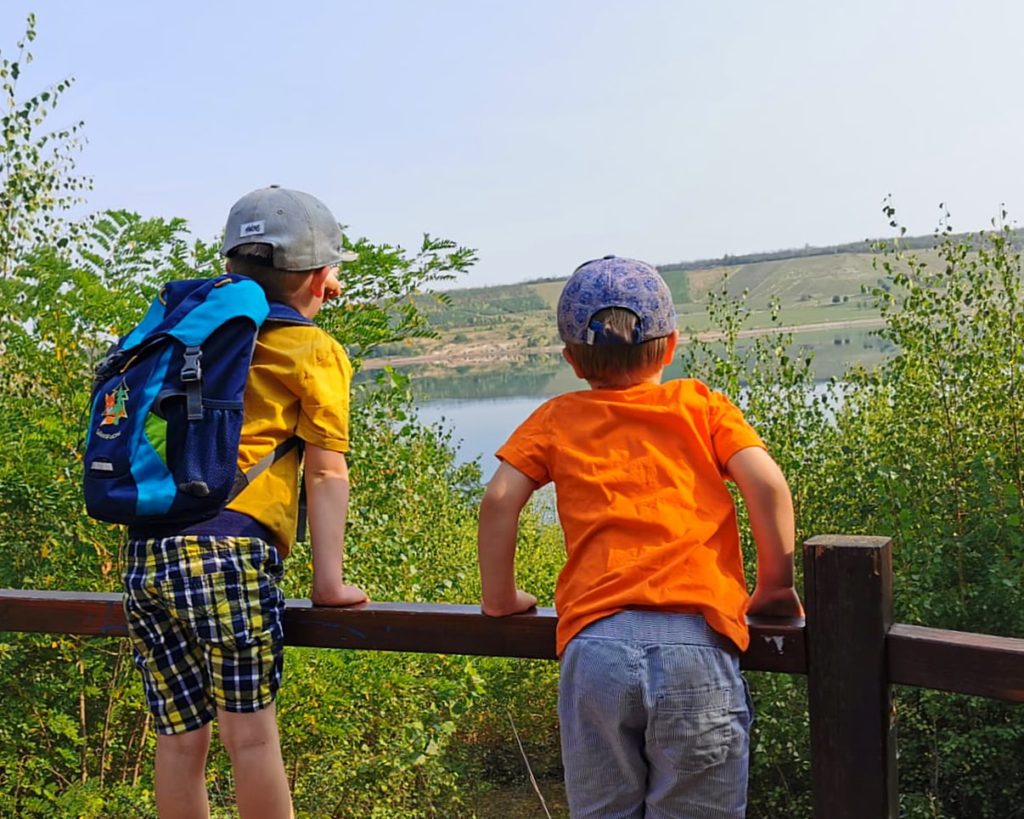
[558,256,676,345]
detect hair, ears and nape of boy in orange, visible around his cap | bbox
[565,307,669,384]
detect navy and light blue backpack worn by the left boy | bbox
[84,273,312,525]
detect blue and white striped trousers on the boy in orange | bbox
[558,610,754,819]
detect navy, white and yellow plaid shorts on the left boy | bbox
[124,534,285,734]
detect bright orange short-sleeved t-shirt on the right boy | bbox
[498,379,764,655]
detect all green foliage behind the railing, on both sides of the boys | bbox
[0,12,1024,819]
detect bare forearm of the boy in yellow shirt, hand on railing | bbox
[305,443,368,606]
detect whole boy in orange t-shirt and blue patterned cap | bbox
[478,256,803,819]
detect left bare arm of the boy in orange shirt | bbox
[476,463,537,617]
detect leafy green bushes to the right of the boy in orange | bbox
[684,204,1024,818]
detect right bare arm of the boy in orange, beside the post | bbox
[726,446,804,617]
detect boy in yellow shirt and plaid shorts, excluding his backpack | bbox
[125,186,367,819]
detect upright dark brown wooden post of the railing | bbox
[804,535,898,819]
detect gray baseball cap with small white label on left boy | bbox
[220,185,356,270]
